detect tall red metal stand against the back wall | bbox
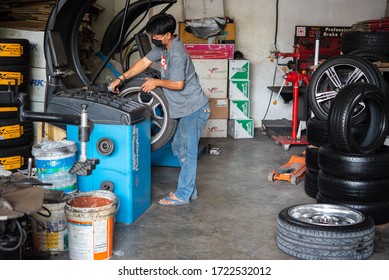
[272,45,309,151]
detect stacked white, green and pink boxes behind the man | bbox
[179,20,254,138]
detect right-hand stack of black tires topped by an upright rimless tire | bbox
[317,83,389,225]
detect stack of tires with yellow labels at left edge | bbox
[0,38,34,171]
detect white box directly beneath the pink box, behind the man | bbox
[193,59,228,80]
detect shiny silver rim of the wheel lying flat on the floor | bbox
[288,204,364,226]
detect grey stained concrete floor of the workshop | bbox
[50,134,389,260]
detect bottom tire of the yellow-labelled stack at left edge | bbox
[0,143,32,171]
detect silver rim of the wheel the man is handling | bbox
[120,87,168,145]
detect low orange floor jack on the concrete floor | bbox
[267,152,307,185]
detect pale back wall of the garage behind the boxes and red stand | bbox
[98,0,387,127]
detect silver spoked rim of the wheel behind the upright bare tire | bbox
[314,64,369,117]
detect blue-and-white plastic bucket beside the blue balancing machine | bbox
[32,140,77,193]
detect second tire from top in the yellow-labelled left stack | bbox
[0,65,30,92]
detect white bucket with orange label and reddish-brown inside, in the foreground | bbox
[65,191,117,260]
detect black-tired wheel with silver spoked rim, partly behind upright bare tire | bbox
[307,55,386,122]
